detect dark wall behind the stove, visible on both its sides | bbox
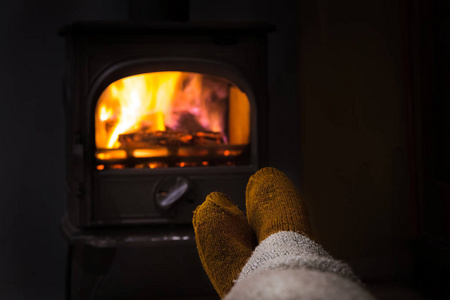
[0,0,444,299]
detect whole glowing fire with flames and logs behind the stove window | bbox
[95,72,250,168]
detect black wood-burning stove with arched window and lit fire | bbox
[62,23,272,299]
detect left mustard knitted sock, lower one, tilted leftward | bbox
[192,192,256,298]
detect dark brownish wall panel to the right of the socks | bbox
[299,0,415,281]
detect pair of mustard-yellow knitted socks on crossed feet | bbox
[192,168,311,298]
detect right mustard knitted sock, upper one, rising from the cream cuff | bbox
[246,168,312,242]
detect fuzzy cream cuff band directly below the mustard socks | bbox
[237,231,359,282]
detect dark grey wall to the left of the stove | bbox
[0,0,127,300]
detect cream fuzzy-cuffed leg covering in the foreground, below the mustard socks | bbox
[224,231,374,300]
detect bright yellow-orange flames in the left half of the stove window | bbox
[96,72,183,149]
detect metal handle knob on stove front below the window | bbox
[155,177,189,210]
